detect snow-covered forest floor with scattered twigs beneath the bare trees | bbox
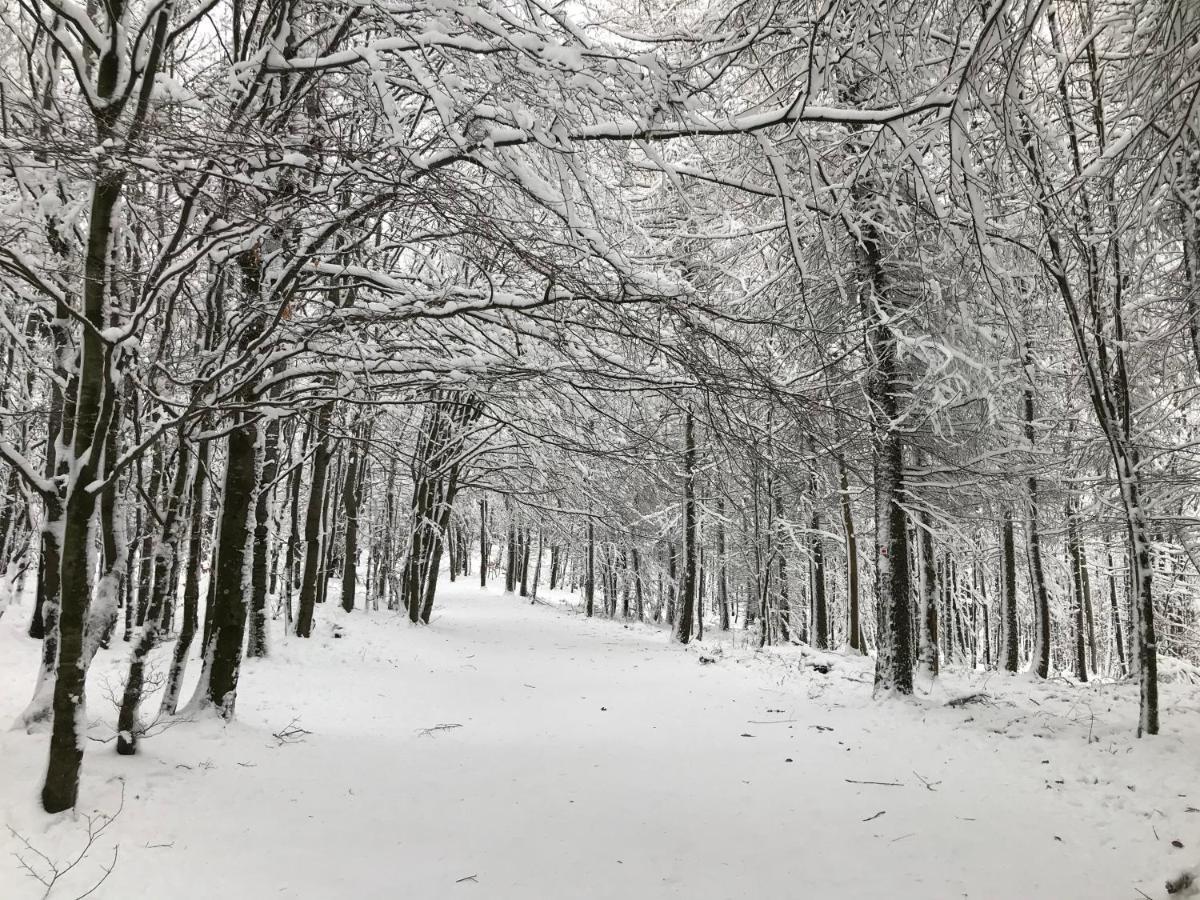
[0,582,1200,900]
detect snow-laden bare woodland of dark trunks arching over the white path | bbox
[0,0,1200,896]
